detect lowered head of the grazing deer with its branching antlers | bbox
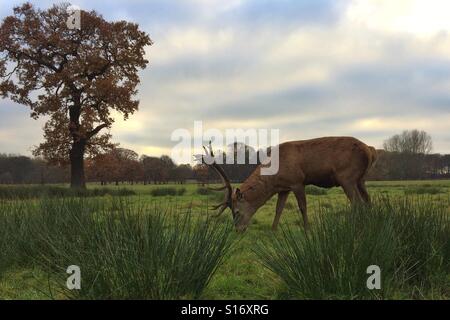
[204,142,256,232]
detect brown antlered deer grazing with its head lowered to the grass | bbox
[205,137,377,231]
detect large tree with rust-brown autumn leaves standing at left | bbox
[0,3,152,188]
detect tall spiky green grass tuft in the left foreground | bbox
[0,198,232,299]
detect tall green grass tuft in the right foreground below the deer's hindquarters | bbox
[255,198,450,299]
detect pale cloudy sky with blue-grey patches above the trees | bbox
[0,0,450,160]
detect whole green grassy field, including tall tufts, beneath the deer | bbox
[0,181,450,299]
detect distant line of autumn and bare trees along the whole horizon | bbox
[0,130,450,185]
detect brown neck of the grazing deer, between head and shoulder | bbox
[240,168,277,210]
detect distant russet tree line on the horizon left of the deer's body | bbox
[0,144,256,185]
